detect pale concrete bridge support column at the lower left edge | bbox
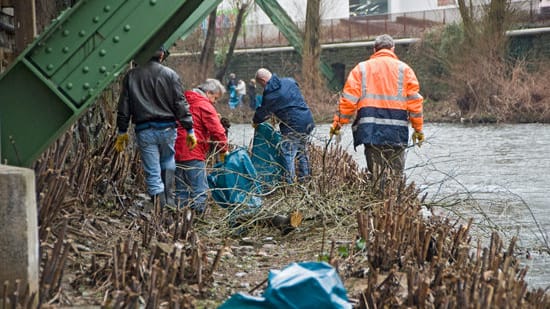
[0,164,39,308]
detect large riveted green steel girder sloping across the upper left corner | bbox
[0,0,215,167]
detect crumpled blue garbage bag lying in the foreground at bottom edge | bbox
[219,262,352,309]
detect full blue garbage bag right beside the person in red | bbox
[207,148,262,215]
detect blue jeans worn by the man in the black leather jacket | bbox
[136,128,176,196]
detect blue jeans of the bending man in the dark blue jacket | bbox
[281,133,311,183]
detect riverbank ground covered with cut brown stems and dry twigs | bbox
[23,122,550,308]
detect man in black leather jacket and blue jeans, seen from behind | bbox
[115,48,197,206]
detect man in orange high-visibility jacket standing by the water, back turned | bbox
[330,34,424,177]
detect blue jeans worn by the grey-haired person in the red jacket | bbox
[176,160,208,213]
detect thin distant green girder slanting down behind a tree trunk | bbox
[255,0,341,90]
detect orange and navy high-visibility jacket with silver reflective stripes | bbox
[334,49,423,146]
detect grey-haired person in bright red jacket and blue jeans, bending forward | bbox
[175,79,228,214]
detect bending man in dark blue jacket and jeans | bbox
[252,68,315,183]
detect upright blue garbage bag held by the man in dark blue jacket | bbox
[252,122,285,192]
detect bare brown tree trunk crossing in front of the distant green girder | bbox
[302,0,323,90]
